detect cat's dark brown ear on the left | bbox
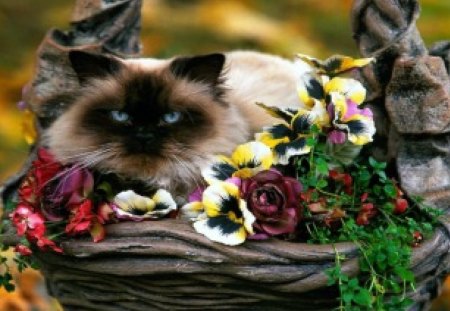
[69,51,123,83]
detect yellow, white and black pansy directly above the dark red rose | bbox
[202,141,273,184]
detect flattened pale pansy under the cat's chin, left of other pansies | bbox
[111,189,177,221]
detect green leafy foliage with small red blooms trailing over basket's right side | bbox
[297,135,441,311]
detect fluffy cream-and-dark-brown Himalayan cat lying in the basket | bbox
[45,51,302,199]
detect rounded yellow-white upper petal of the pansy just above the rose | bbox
[231,141,273,170]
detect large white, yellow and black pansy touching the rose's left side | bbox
[181,182,255,245]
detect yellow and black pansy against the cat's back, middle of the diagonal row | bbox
[255,100,329,165]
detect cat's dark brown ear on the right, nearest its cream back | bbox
[170,53,225,86]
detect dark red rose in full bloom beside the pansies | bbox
[241,169,302,238]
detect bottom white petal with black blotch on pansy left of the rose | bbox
[194,216,247,246]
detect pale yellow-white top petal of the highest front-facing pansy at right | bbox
[325,77,366,105]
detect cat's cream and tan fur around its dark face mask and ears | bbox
[46,51,302,194]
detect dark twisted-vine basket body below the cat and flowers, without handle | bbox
[29,220,450,311]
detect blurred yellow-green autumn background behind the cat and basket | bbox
[0,0,450,311]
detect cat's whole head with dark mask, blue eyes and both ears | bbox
[46,52,246,193]
